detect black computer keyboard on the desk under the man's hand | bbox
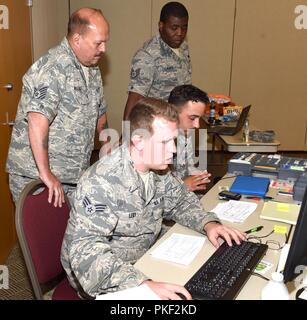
[185,241,268,300]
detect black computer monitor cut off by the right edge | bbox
[283,188,307,282]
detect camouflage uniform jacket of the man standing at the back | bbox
[128,34,192,100]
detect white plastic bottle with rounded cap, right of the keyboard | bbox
[261,272,289,300]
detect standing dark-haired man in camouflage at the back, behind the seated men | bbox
[124,1,192,120]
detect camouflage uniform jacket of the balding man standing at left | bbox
[7,38,106,183]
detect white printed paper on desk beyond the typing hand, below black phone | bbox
[211,200,257,223]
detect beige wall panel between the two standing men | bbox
[70,0,151,138]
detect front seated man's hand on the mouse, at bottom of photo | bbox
[143,280,192,300]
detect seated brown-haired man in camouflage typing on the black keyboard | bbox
[61,99,244,299]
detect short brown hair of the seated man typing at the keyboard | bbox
[128,98,179,136]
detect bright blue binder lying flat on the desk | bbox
[229,176,270,197]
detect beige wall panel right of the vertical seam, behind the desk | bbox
[231,0,307,150]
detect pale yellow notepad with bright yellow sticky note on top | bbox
[260,201,301,225]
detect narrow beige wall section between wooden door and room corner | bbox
[32,0,69,61]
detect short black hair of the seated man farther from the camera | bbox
[168,84,209,108]
